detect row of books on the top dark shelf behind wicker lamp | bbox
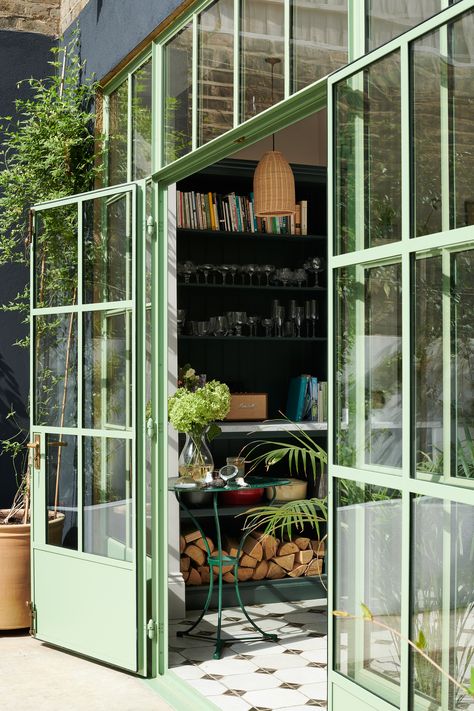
[176,190,308,235]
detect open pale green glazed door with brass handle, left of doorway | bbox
[31,185,146,673]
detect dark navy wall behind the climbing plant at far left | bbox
[0,30,53,508]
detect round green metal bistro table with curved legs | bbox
[168,476,290,659]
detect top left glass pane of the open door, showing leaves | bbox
[34,204,77,308]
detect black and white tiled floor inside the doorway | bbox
[169,600,327,711]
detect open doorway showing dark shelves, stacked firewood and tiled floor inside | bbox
[168,111,328,709]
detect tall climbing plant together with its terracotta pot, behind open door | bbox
[0,32,102,629]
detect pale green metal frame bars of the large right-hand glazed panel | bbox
[328,0,474,711]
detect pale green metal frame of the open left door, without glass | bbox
[30,182,147,675]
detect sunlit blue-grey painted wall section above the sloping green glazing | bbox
[72,0,181,79]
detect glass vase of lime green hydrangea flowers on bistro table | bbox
[168,365,230,482]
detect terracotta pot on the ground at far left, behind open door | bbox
[0,509,64,630]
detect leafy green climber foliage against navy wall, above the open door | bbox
[0,32,101,312]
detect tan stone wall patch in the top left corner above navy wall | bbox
[0,0,60,36]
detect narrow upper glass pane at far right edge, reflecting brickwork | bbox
[449,12,474,227]
